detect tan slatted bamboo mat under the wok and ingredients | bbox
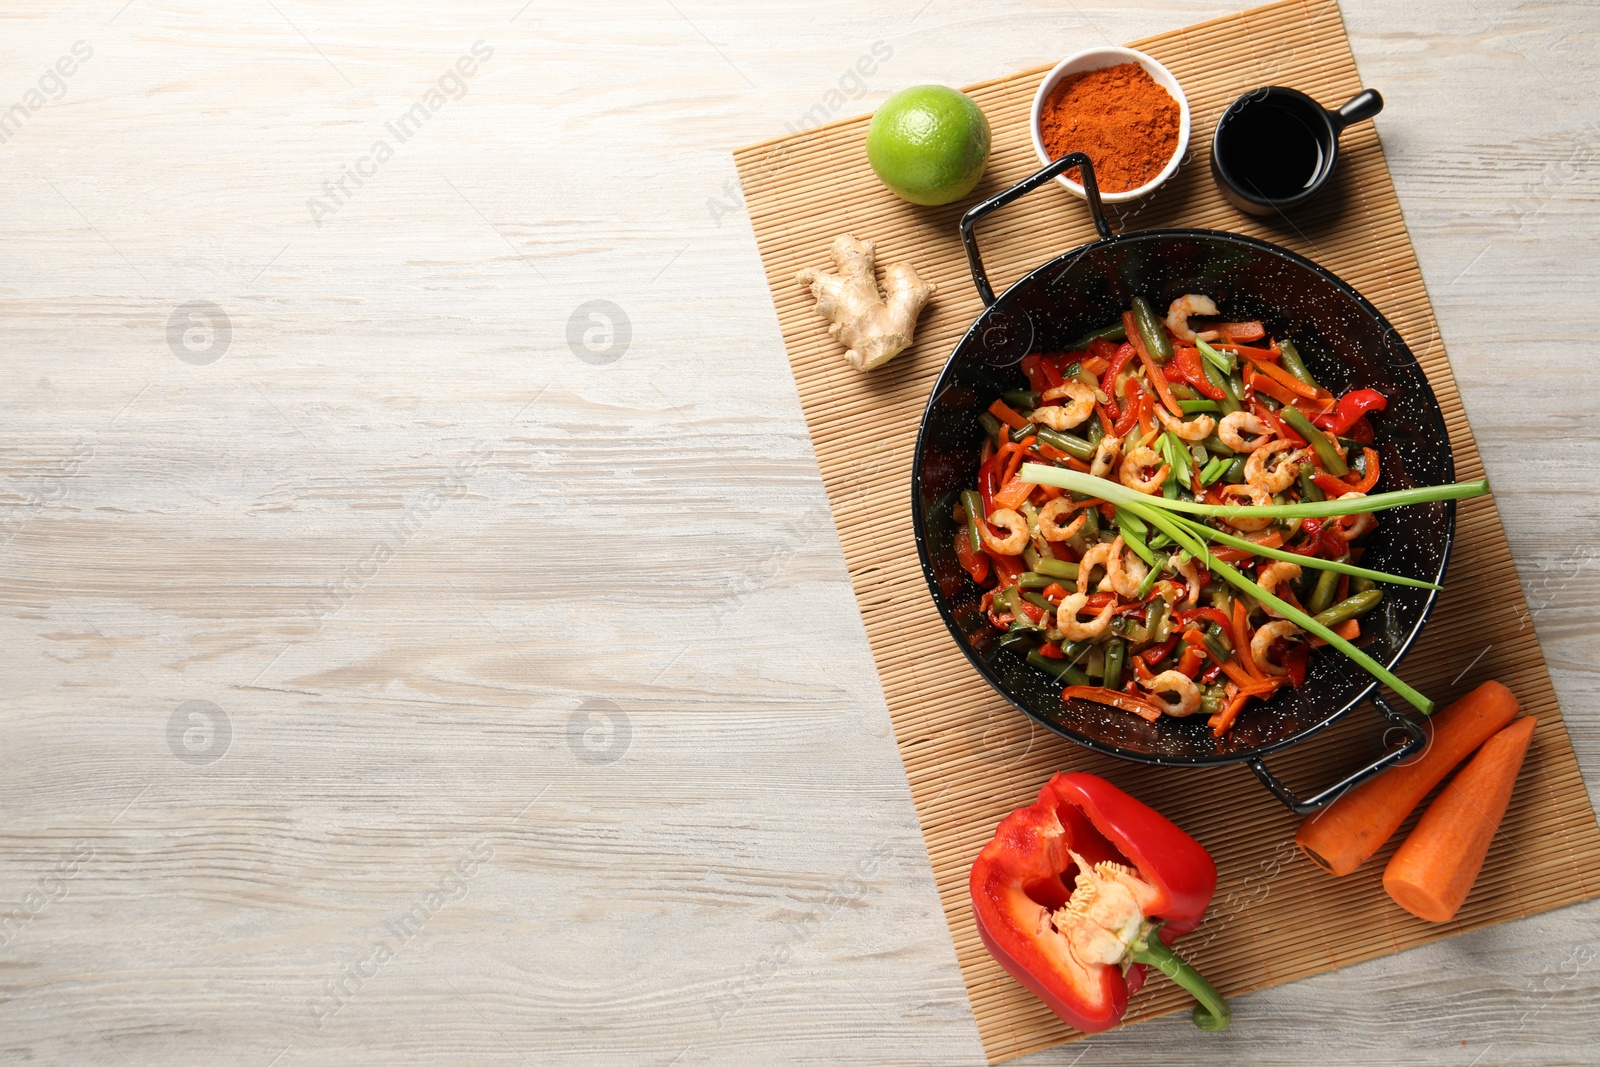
[736,0,1600,1061]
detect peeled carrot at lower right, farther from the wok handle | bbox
[1384,717,1534,923]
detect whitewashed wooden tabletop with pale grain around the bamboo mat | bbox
[0,0,1600,1067]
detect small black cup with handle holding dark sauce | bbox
[1211,85,1384,214]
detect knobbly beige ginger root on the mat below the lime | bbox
[795,234,938,371]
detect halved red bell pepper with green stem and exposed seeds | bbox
[968,774,1232,1033]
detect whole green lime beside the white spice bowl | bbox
[867,85,989,205]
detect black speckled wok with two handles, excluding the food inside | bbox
[912,154,1456,813]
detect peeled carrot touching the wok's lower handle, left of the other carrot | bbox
[1294,681,1517,877]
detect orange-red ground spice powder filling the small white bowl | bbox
[1038,62,1179,192]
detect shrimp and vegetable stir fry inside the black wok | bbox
[954,293,1384,736]
